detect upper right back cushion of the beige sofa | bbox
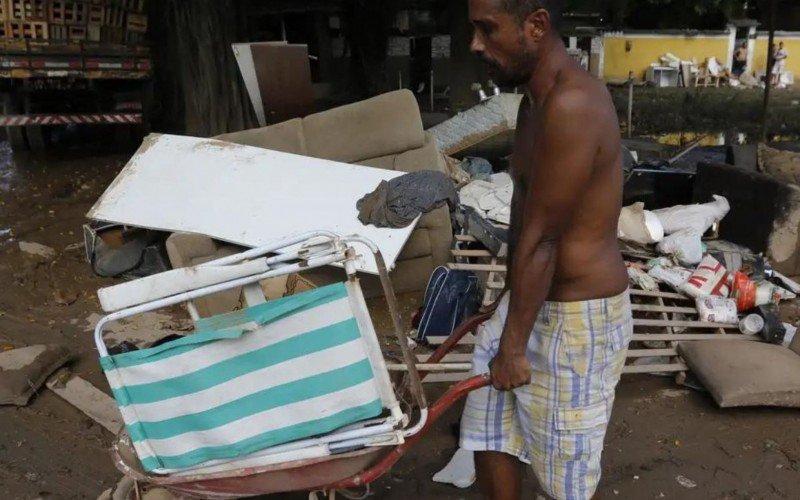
[303,90,425,163]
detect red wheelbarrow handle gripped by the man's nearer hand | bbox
[324,375,489,490]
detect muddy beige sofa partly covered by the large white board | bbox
[169,90,453,304]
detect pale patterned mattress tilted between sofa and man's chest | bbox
[428,94,522,155]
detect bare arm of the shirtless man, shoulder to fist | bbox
[491,91,601,390]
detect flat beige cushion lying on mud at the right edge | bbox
[678,340,800,408]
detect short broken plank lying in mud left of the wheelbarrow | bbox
[47,368,124,436]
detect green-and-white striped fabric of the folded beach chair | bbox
[100,284,382,473]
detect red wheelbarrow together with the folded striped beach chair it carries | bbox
[95,231,490,498]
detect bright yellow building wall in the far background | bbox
[590,26,800,84]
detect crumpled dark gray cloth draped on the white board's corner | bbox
[356,170,458,228]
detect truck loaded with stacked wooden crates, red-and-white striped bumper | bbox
[0,0,152,151]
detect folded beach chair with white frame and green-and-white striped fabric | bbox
[95,232,424,475]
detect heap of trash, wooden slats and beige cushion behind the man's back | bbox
[618,196,800,407]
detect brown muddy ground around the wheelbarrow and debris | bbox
[0,144,800,500]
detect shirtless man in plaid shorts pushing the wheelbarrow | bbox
[461,0,633,500]
